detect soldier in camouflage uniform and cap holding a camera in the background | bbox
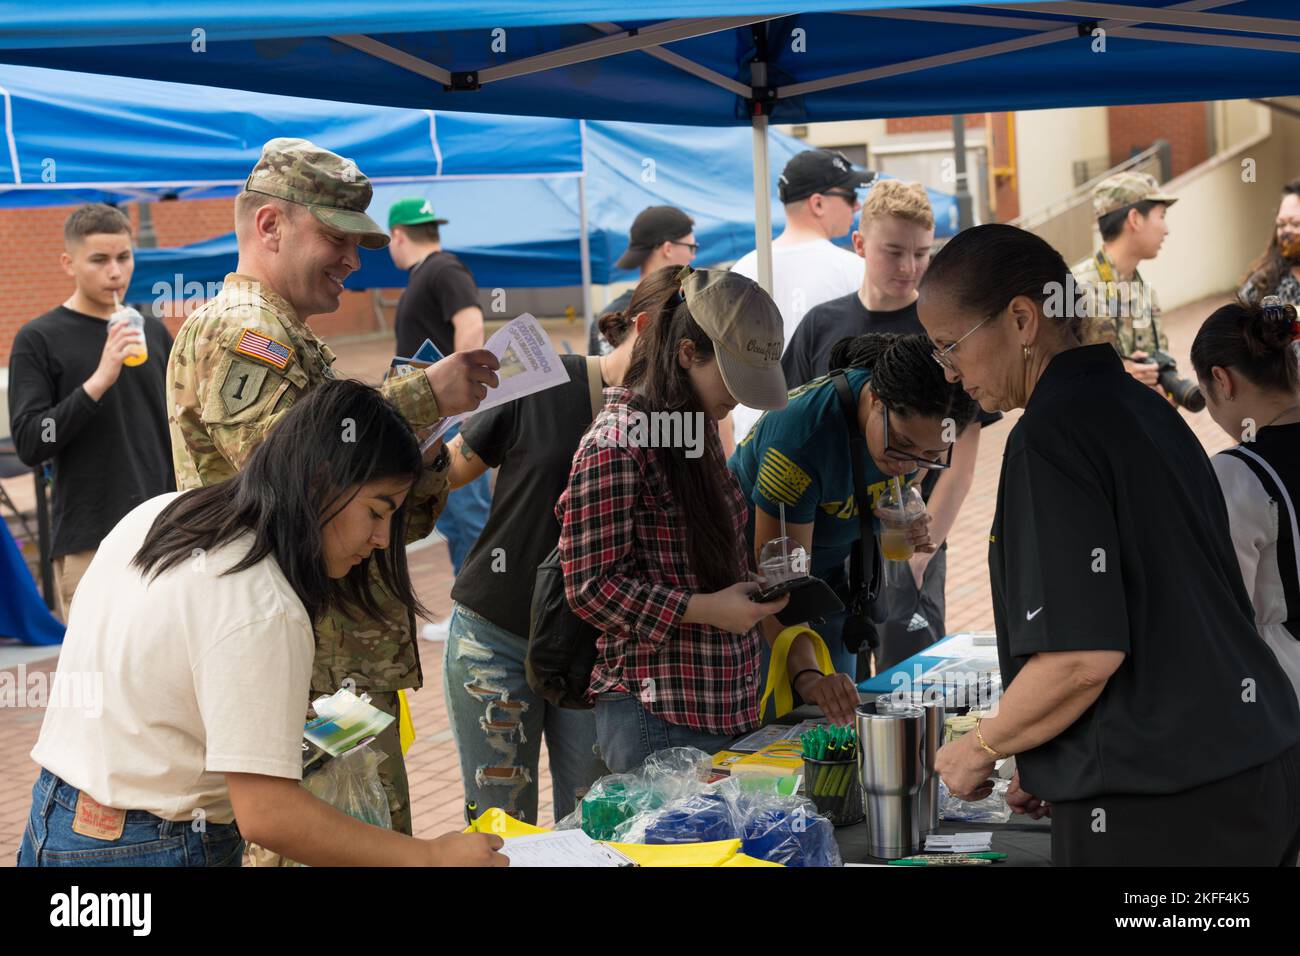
[1073,172,1178,386]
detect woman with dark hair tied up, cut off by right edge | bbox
[1192,302,1300,697]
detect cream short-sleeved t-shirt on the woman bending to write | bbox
[31,492,316,823]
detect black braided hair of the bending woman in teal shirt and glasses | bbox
[829,332,979,432]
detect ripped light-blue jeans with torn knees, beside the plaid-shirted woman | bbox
[442,604,607,823]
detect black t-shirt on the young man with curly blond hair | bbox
[781,293,1002,501]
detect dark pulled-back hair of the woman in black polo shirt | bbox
[918,222,1086,338]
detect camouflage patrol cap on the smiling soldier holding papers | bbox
[244,137,389,248]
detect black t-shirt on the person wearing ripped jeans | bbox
[451,355,592,639]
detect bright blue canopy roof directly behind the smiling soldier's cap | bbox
[0,66,582,208]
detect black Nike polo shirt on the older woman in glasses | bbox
[988,345,1300,801]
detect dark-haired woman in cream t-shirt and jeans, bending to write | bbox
[18,381,507,866]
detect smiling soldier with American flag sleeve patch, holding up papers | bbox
[166,138,497,834]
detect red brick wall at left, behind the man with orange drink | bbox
[0,199,377,367]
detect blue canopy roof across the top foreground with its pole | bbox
[0,0,1300,285]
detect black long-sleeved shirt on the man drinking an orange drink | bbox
[9,306,176,557]
